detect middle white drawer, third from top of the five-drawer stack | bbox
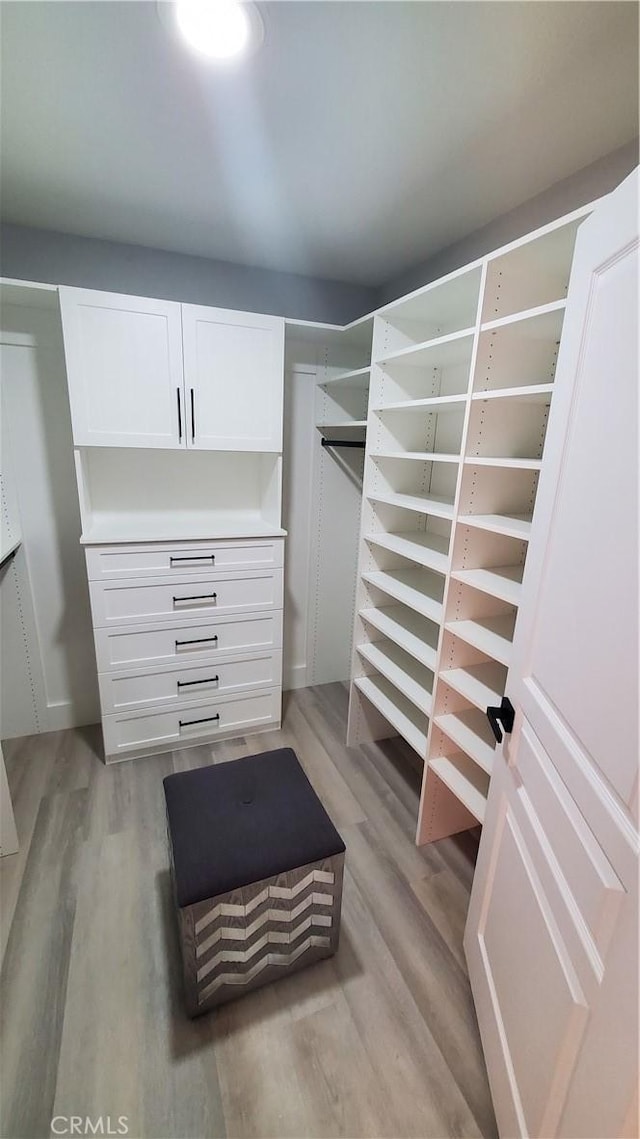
[93,609,282,672]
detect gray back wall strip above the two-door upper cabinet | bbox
[0,223,377,325]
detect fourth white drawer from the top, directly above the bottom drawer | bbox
[98,653,282,714]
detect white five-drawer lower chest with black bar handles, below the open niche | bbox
[87,539,284,762]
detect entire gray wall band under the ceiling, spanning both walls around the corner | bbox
[0,140,638,323]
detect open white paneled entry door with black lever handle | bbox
[465,168,639,1139]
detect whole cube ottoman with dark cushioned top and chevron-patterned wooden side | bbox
[164,747,345,1016]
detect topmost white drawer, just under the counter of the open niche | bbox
[85,539,284,581]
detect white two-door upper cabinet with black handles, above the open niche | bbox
[60,288,285,452]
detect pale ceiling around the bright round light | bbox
[0,0,638,285]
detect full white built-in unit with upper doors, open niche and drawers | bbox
[60,288,285,762]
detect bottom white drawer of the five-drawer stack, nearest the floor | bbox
[102,688,281,760]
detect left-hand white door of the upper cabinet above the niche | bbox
[59,288,186,448]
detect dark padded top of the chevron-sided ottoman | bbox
[164,747,345,907]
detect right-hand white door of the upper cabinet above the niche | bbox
[182,304,285,451]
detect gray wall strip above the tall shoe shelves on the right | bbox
[378,139,638,305]
